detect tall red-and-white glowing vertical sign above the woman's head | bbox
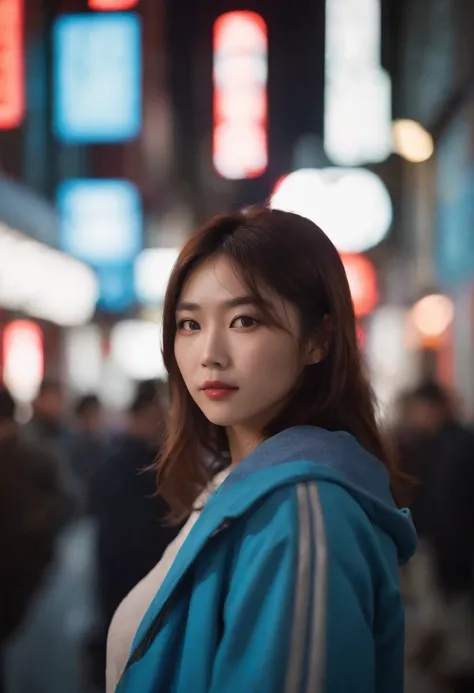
[213,11,268,180]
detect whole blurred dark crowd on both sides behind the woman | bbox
[0,381,474,693]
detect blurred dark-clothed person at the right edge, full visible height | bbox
[400,381,474,691]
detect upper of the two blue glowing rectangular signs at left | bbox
[53,13,142,143]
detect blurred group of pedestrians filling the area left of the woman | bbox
[0,381,179,693]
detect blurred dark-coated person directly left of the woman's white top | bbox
[92,383,184,628]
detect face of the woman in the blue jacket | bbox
[175,255,317,433]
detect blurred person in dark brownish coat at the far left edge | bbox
[0,388,62,690]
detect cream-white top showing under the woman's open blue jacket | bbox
[106,469,230,693]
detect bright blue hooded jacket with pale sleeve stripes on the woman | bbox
[117,426,416,693]
